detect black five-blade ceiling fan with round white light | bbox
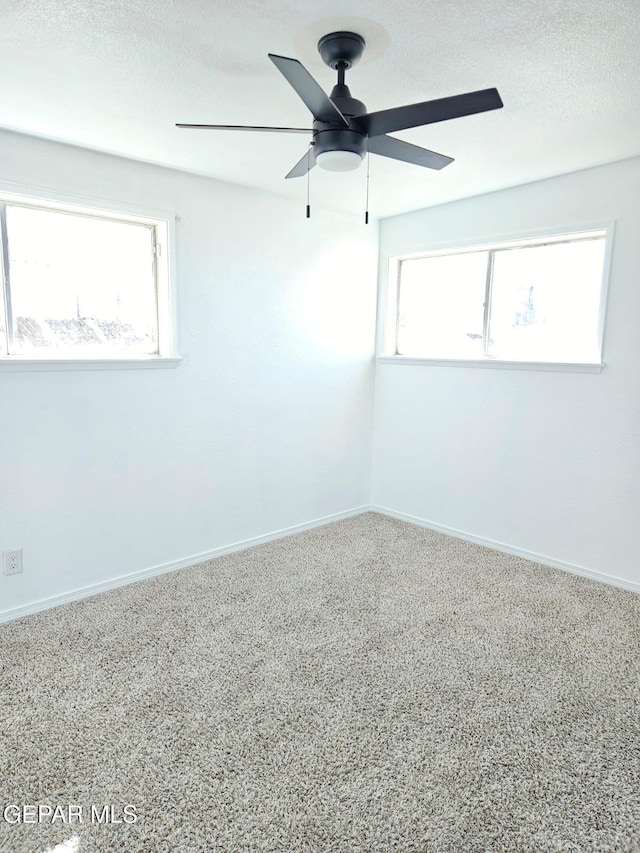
[176,31,503,178]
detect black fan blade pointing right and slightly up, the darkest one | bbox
[357,89,503,136]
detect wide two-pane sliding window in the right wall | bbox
[385,230,607,364]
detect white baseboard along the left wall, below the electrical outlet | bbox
[0,506,371,625]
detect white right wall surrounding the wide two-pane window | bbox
[373,159,640,583]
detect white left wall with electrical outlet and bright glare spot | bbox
[0,132,377,617]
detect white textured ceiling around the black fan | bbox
[0,0,640,216]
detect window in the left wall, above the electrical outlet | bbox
[0,195,171,361]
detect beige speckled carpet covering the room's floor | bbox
[0,514,640,853]
